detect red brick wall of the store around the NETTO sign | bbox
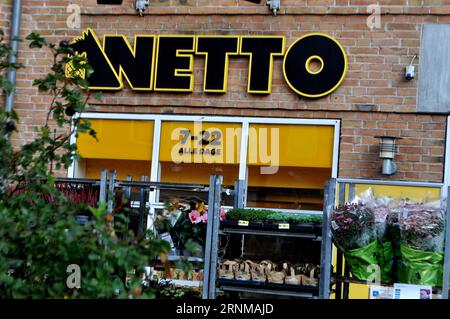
[6,0,450,182]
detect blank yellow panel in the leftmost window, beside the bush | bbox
[77,120,154,160]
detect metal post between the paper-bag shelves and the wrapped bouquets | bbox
[319,178,336,299]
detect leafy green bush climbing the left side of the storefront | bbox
[0,33,170,298]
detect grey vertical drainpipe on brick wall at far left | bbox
[5,0,22,112]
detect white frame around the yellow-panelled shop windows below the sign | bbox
[67,112,341,215]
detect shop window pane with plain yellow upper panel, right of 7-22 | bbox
[247,124,334,210]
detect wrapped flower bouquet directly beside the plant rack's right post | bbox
[330,202,378,280]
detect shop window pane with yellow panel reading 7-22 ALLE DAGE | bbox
[159,121,241,205]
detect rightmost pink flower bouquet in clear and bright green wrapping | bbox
[399,203,445,286]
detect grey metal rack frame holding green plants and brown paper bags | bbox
[203,175,333,299]
